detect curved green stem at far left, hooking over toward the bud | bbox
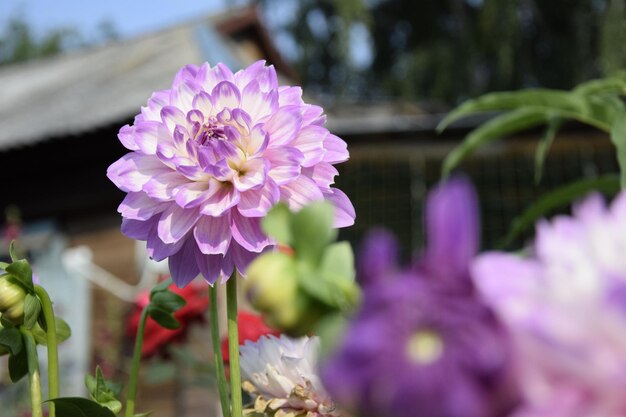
[35,285,59,417]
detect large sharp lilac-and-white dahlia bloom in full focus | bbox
[107,61,354,286]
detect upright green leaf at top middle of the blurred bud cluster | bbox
[291,201,337,266]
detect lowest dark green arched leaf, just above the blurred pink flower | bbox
[498,175,620,247]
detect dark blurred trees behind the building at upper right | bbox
[260,0,626,104]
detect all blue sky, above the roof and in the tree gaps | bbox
[0,0,372,67]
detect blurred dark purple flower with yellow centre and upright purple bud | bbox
[322,178,515,417]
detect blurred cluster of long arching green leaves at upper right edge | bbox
[437,73,626,185]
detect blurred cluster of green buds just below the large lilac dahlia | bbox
[244,202,359,336]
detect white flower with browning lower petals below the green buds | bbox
[240,335,345,417]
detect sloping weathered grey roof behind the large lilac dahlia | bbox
[0,8,293,150]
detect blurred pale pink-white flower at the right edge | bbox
[472,192,626,417]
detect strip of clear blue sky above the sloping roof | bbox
[0,0,232,38]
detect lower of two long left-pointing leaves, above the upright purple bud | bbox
[442,108,549,177]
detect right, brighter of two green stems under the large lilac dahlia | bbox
[226,274,243,417]
